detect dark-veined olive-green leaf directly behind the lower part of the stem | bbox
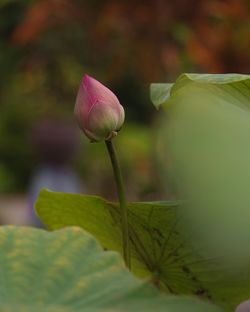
[36,190,247,311]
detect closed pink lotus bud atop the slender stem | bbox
[75,75,125,142]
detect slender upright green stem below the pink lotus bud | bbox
[105,141,131,269]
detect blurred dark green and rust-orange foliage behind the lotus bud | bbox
[0,0,250,199]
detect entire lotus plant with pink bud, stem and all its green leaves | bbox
[0,74,250,312]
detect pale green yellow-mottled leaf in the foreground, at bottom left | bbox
[0,226,219,312]
